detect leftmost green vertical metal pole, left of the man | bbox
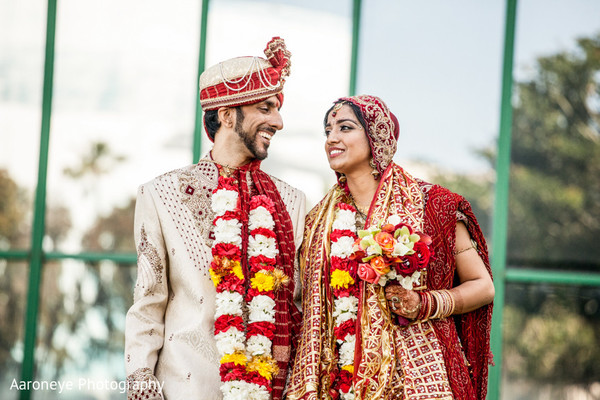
[20,0,57,400]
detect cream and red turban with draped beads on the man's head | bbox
[200,37,291,111]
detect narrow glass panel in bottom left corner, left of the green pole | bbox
[0,259,29,400]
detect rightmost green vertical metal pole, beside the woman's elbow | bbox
[489,0,517,400]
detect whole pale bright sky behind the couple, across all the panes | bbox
[0,0,600,250]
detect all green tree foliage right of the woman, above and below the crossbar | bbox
[434,35,600,398]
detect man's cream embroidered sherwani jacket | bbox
[125,158,305,400]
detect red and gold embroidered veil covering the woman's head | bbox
[336,95,400,175]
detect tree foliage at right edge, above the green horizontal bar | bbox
[508,35,600,271]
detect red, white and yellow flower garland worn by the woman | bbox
[330,203,358,400]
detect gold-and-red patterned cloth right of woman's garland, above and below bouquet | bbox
[355,164,452,400]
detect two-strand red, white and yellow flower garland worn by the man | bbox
[210,176,289,400]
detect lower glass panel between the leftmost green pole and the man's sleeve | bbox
[32,260,136,399]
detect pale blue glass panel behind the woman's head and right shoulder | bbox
[358,0,504,239]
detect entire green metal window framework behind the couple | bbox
[0,0,600,400]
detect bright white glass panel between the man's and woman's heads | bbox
[203,0,352,207]
